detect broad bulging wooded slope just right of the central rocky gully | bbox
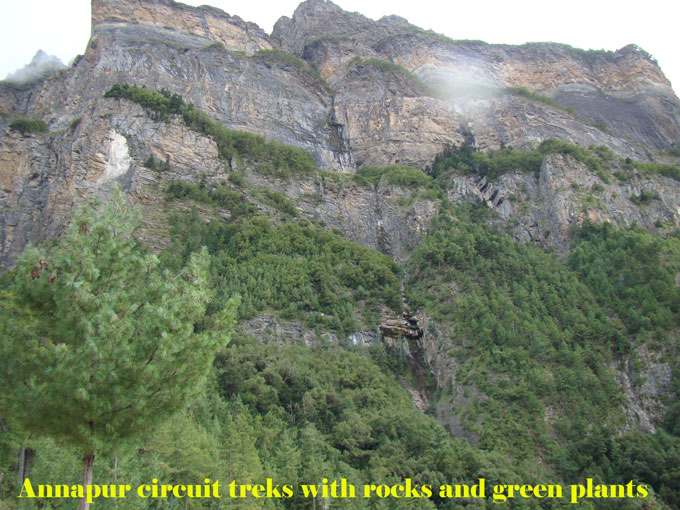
[407,209,627,474]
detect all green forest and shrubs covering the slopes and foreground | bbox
[0,85,680,510]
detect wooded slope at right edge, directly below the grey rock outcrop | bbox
[568,223,680,338]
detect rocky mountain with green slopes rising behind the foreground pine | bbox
[0,0,680,508]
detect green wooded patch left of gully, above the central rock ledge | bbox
[163,212,401,333]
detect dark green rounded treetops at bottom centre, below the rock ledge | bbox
[216,342,512,510]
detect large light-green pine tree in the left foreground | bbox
[0,189,236,509]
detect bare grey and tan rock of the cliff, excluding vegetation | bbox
[0,0,680,440]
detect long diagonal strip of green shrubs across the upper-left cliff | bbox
[104,84,316,178]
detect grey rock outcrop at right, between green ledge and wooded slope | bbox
[448,154,680,254]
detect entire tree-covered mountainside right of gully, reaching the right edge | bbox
[407,209,680,508]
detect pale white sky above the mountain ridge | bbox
[0,0,680,93]
